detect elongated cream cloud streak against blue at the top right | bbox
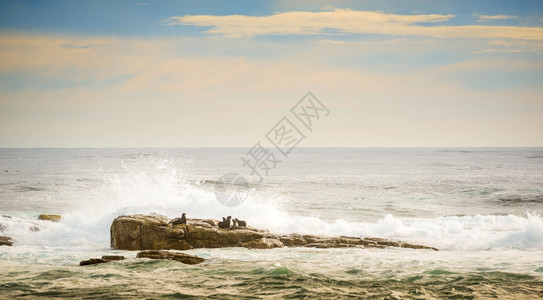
[163,9,543,40]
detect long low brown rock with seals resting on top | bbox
[111,215,437,250]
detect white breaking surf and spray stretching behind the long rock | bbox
[0,182,543,250]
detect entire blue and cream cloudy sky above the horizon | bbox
[0,0,543,147]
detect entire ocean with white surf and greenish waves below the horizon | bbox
[0,148,543,299]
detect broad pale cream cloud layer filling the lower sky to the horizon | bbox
[0,34,543,147]
